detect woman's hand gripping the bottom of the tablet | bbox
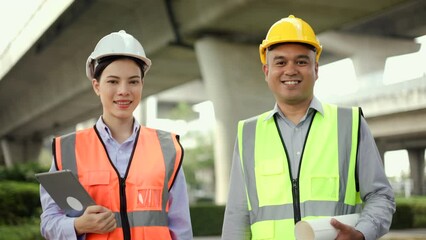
[74,205,117,235]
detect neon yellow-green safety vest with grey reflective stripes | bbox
[238,104,361,239]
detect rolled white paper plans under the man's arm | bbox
[294,214,359,240]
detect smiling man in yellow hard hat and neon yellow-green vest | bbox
[222,15,395,240]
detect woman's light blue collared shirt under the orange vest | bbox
[40,117,193,240]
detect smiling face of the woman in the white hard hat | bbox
[92,58,143,122]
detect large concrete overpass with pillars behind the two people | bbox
[0,0,426,202]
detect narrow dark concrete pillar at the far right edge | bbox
[407,148,426,195]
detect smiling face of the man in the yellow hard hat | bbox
[263,43,318,105]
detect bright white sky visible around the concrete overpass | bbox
[0,0,426,176]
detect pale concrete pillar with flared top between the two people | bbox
[195,37,275,204]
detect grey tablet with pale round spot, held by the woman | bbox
[35,170,96,217]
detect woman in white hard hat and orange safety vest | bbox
[40,30,192,240]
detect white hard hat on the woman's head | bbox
[86,30,151,80]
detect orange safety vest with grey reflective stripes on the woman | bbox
[53,126,183,240]
